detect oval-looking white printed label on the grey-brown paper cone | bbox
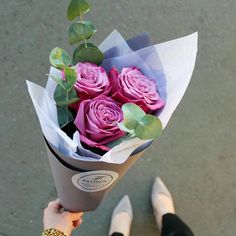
[72,170,119,192]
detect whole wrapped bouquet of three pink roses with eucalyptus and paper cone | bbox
[27,0,197,211]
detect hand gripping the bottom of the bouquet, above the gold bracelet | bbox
[43,199,83,235]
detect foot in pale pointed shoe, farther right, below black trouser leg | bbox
[151,177,175,230]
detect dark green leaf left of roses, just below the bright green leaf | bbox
[54,86,79,106]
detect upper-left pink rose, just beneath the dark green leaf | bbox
[70,62,111,111]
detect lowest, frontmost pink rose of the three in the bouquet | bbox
[74,95,125,151]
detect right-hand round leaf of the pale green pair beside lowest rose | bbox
[134,114,162,140]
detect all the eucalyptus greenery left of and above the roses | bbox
[49,0,104,127]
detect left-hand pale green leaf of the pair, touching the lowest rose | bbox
[122,103,146,130]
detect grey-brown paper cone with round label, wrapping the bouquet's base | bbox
[46,138,144,212]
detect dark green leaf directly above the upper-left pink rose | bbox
[73,43,104,65]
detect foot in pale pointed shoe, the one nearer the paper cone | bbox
[109,195,133,236]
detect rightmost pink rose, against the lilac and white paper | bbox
[109,67,165,113]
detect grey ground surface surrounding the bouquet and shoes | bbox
[0,0,236,236]
